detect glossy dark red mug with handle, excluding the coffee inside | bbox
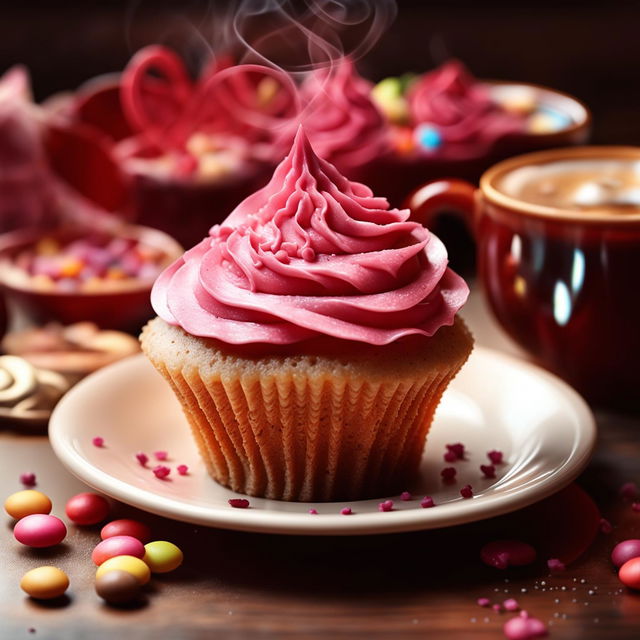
[407,147,640,411]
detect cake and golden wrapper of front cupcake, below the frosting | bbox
[141,318,473,501]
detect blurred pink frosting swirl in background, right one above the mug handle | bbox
[407,60,523,156]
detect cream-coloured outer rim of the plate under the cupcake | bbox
[49,346,596,535]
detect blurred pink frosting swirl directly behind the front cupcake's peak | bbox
[281,58,390,172]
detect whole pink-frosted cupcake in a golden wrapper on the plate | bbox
[141,129,472,501]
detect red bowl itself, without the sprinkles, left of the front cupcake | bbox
[0,225,183,333]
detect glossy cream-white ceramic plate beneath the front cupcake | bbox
[49,347,595,535]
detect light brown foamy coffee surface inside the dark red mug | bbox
[496,158,640,213]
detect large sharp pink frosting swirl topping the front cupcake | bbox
[151,128,468,345]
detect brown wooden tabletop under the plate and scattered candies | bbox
[0,292,640,640]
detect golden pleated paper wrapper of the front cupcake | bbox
[146,358,462,501]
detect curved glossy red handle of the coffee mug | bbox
[404,178,478,237]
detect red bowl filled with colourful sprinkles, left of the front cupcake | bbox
[0,224,182,331]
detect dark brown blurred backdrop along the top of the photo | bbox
[0,0,640,144]
